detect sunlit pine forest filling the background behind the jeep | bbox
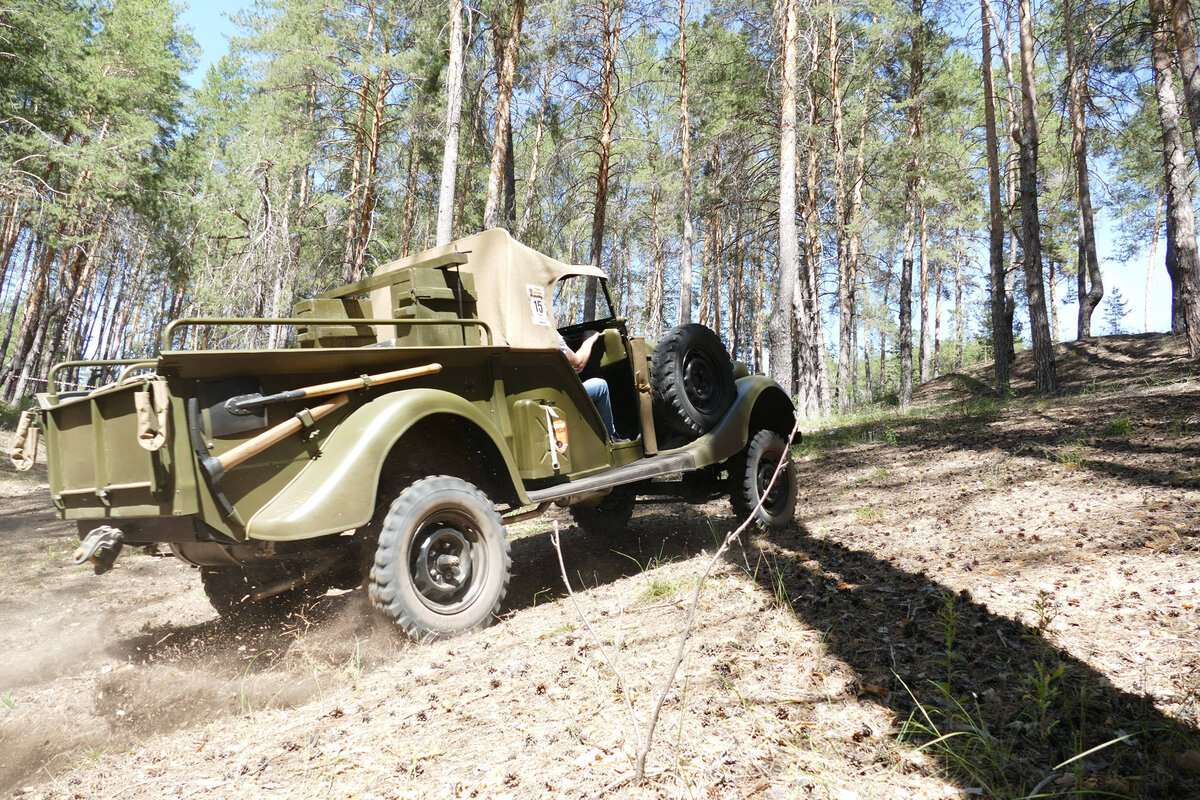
[0,0,1200,417]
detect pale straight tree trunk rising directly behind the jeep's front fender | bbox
[767,0,808,398]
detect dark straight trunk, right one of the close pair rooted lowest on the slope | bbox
[1019,0,1058,395]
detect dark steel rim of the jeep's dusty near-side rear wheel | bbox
[408,510,487,614]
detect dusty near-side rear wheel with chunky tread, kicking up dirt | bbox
[368,475,512,642]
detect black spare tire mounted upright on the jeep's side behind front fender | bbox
[650,324,737,437]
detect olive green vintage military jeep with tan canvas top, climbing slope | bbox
[13,229,797,640]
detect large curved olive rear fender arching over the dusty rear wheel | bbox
[246,389,528,541]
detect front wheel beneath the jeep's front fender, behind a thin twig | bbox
[730,431,799,530]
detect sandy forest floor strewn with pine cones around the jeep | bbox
[0,336,1200,800]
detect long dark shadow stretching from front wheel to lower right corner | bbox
[758,528,1200,798]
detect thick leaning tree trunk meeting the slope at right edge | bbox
[1150,0,1200,359]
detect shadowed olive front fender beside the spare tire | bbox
[679,375,796,468]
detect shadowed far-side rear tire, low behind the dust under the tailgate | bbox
[200,564,332,622]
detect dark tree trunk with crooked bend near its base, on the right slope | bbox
[1070,0,1104,339]
